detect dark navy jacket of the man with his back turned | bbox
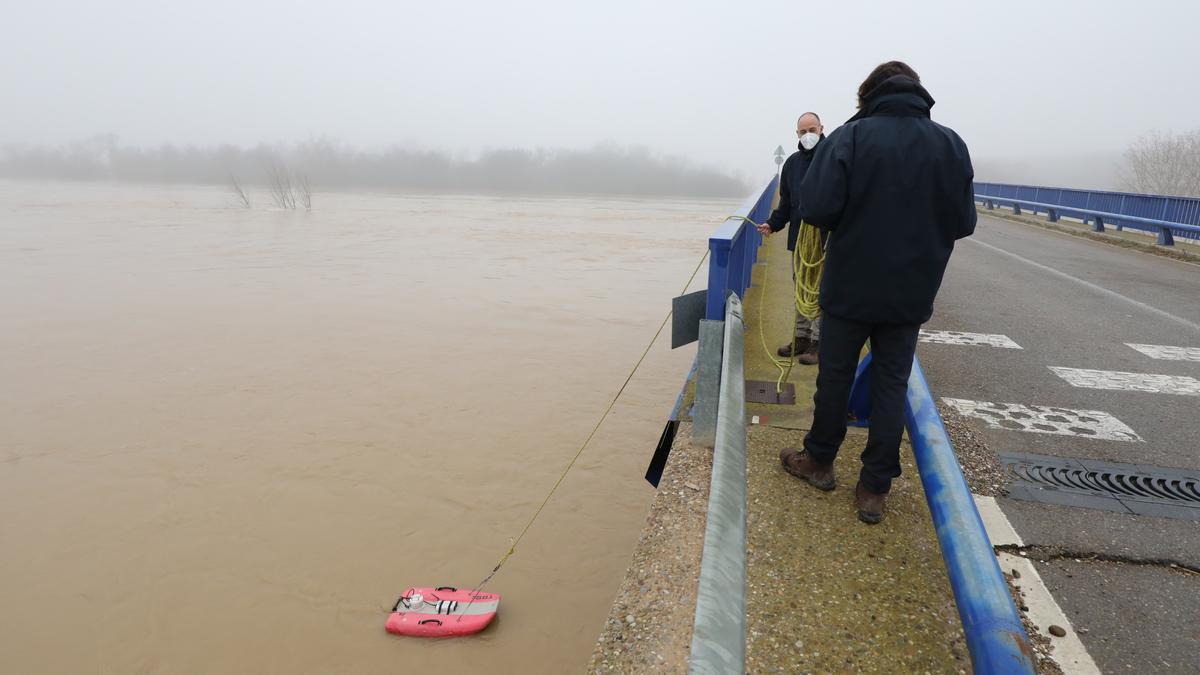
[799,76,976,324]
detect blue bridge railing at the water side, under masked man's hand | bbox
[704,175,779,321]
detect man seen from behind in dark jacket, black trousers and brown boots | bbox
[780,61,976,522]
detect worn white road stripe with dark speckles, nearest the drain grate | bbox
[942,398,1141,443]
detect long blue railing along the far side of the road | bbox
[974,183,1200,246]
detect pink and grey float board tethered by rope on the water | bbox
[384,586,500,638]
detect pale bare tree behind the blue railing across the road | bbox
[1123,129,1200,197]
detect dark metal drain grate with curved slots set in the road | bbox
[998,453,1200,520]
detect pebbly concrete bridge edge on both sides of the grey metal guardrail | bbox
[589,229,971,673]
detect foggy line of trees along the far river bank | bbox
[0,136,749,196]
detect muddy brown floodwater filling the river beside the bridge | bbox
[0,181,734,674]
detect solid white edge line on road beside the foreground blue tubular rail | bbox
[973,495,1100,675]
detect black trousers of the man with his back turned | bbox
[804,313,920,494]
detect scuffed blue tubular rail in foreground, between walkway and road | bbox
[850,353,1033,674]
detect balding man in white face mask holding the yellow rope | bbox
[758,113,824,365]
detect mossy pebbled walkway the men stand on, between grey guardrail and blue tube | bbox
[745,229,971,673]
